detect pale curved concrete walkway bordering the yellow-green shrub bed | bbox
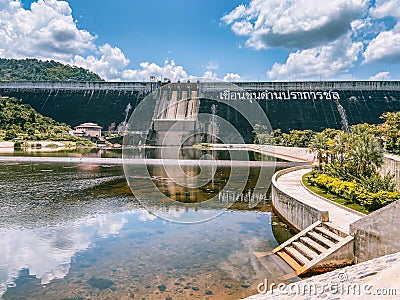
[277,169,362,233]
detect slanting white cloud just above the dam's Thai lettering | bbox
[267,35,363,80]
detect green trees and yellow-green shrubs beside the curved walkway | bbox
[255,112,400,213]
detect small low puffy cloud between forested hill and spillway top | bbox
[121,60,189,81]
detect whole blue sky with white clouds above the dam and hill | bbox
[0,0,400,81]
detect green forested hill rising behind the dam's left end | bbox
[0,58,104,81]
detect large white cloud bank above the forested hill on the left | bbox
[0,0,192,81]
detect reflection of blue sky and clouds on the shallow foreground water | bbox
[0,209,296,299]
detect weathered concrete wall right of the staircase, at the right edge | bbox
[350,201,400,263]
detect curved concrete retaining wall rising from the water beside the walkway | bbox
[272,167,329,231]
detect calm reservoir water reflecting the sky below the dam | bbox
[0,149,296,299]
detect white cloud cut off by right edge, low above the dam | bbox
[363,27,400,63]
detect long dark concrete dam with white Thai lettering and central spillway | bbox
[0,81,400,142]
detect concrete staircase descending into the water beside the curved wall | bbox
[272,222,354,275]
